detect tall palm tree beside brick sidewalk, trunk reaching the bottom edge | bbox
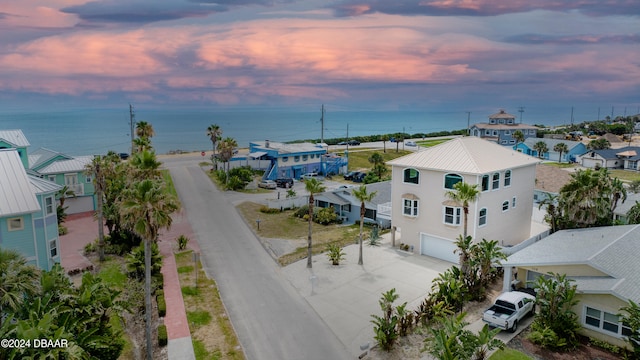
[120,179,178,359]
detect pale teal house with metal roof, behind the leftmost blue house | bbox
[29,148,96,214]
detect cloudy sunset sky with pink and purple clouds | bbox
[0,0,640,116]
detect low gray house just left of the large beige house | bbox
[314,181,391,229]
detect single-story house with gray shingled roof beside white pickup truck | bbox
[502,225,640,346]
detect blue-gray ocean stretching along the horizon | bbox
[0,107,568,155]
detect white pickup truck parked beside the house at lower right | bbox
[482,291,536,332]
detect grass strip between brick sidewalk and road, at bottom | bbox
[175,250,245,360]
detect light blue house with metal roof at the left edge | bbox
[0,148,62,270]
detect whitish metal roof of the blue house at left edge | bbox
[0,149,40,217]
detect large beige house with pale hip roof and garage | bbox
[387,136,539,263]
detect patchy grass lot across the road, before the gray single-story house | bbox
[238,202,370,266]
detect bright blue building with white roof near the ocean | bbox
[248,140,348,180]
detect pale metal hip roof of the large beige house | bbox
[387,136,540,174]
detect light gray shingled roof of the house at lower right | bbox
[503,225,640,302]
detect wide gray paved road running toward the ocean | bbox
[164,157,351,360]
